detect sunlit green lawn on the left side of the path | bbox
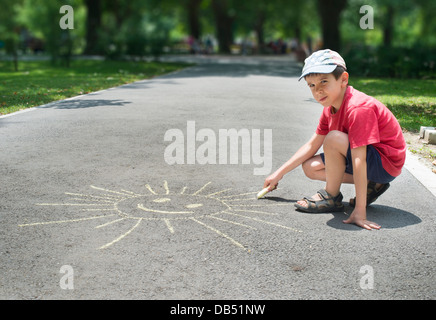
[0,60,188,114]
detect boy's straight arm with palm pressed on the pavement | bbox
[344,146,380,230]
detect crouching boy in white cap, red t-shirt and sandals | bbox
[264,49,406,230]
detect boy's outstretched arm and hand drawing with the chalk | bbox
[263,133,325,190]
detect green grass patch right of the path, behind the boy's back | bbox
[350,77,436,132]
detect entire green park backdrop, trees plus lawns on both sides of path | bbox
[0,0,436,159]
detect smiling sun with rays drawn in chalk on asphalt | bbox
[19,180,302,251]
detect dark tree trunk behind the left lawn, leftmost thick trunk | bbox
[84,0,101,54]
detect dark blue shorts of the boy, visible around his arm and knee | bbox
[320,145,395,184]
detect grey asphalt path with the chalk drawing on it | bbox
[0,57,436,299]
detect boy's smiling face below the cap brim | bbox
[306,72,348,109]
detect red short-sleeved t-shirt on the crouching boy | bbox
[316,86,406,177]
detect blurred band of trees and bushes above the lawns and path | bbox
[0,0,436,66]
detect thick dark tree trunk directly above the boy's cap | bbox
[318,0,347,51]
